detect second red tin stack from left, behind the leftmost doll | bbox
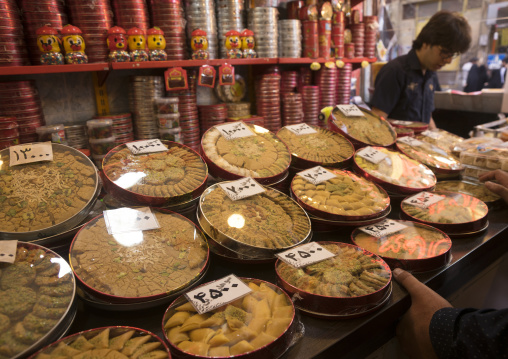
[18,0,68,65]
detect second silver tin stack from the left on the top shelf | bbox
[216,0,245,59]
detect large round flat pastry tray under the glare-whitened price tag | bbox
[70,209,209,305]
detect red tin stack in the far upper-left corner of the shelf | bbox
[0,0,30,66]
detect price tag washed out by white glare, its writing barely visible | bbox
[104,207,160,235]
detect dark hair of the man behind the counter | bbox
[413,10,471,54]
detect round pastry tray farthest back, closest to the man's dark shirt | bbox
[328,108,397,149]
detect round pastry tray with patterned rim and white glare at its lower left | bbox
[103,142,208,206]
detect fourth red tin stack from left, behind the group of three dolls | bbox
[111,0,150,33]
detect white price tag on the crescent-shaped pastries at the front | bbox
[185,274,252,314]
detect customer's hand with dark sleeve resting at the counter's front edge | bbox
[393,268,452,359]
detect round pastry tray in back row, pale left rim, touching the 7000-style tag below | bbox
[201,125,291,185]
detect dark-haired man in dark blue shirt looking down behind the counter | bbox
[371,11,471,129]
